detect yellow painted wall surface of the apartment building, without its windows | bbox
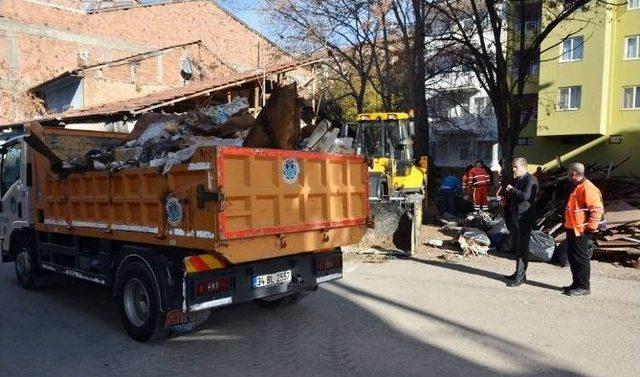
[516,6,640,175]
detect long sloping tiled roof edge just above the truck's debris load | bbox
[5,58,323,126]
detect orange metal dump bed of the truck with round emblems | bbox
[35,147,368,264]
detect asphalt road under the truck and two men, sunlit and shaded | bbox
[0,254,640,377]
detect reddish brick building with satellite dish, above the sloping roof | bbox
[0,0,293,124]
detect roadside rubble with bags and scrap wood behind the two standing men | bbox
[426,160,640,267]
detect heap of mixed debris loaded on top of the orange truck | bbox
[55,84,353,174]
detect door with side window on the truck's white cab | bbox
[0,141,28,261]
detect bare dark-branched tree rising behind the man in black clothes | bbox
[425,0,620,184]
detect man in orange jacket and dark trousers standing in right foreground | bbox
[563,163,604,296]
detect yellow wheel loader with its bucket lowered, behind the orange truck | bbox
[355,113,427,254]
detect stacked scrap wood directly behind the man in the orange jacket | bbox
[537,159,640,260]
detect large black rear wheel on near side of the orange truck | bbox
[117,262,162,342]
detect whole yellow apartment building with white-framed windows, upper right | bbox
[516,0,640,175]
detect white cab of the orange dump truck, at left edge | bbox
[0,128,28,262]
